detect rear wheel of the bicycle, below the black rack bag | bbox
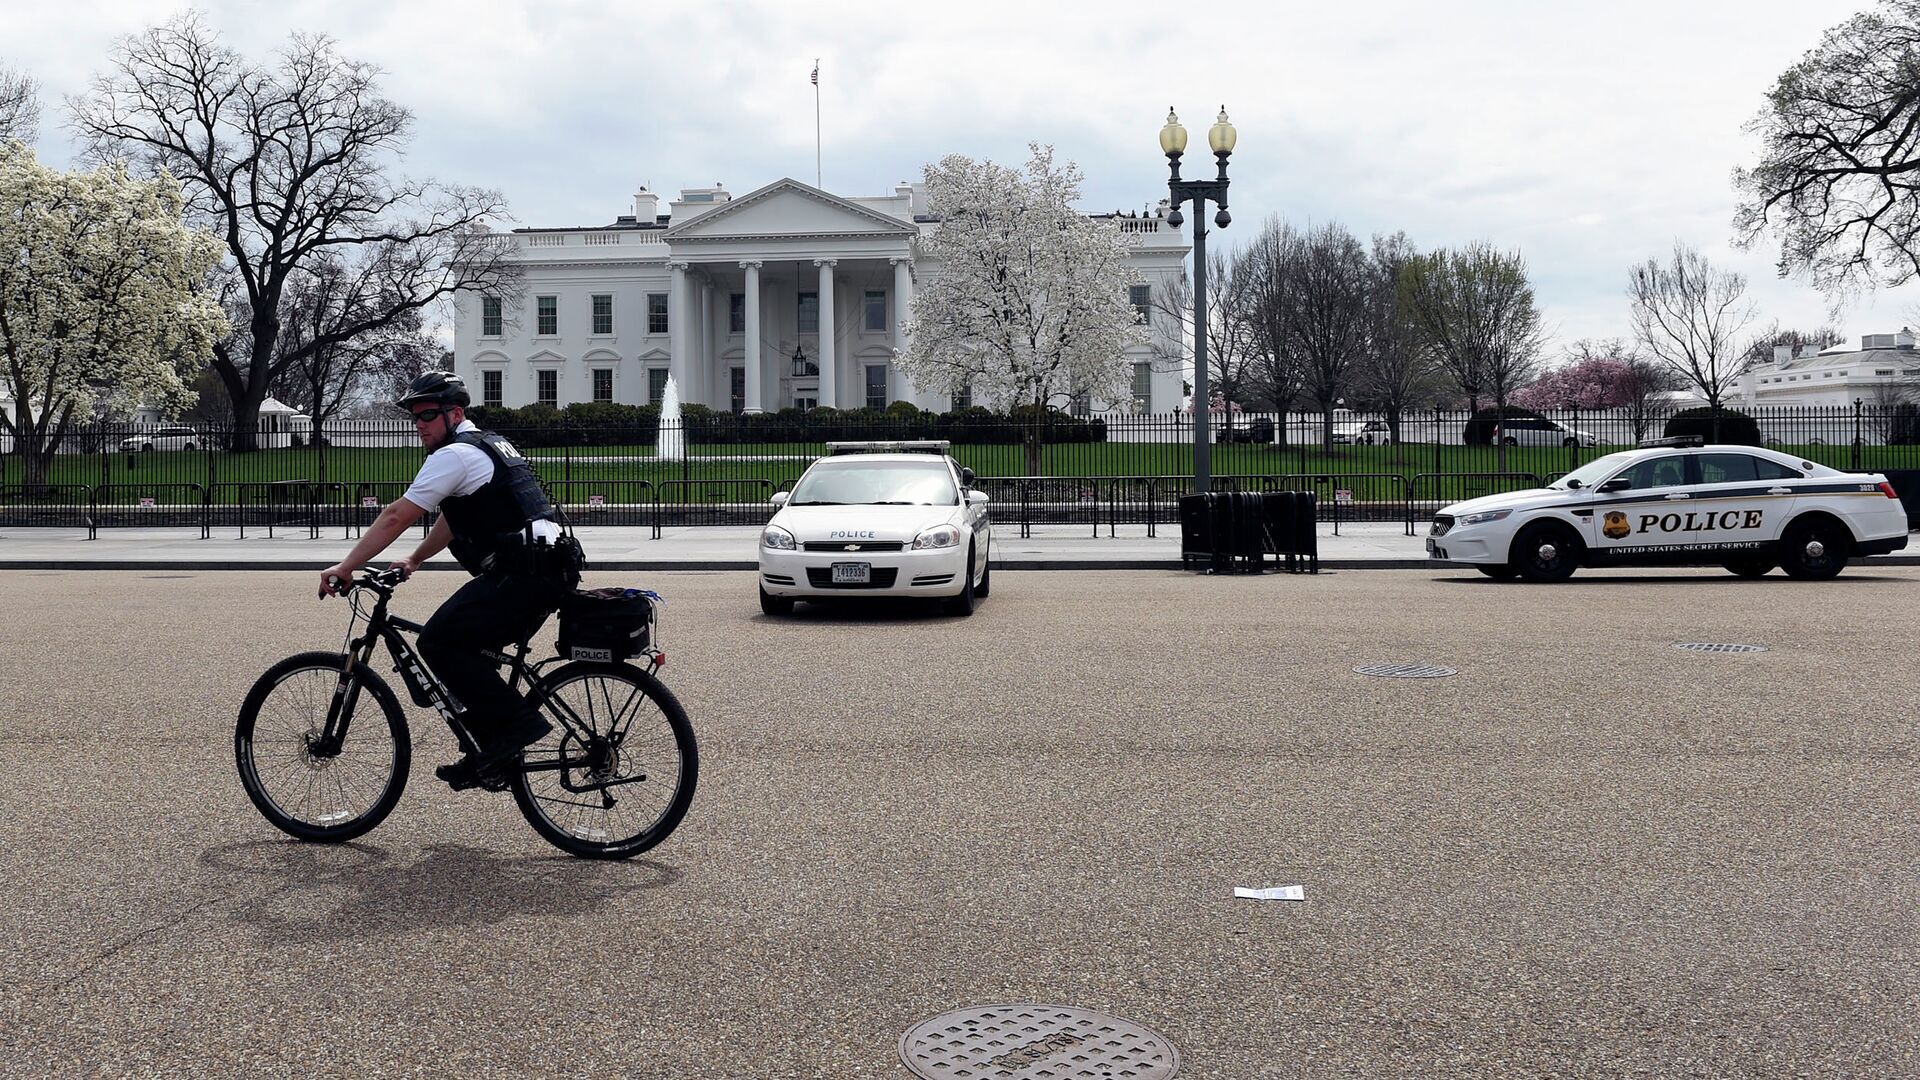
[513,663,699,859]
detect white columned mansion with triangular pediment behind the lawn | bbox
[453,179,1188,411]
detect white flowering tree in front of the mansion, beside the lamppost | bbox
[899,144,1148,475]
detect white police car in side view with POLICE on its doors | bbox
[1427,438,1907,580]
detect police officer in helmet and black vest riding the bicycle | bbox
[321,371,582,790]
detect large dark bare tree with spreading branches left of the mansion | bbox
[71,15,516,450]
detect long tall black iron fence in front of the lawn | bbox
[11,402,1920,534]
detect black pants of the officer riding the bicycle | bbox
[420,575,561,749]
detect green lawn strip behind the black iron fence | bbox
[0,432,1920,502]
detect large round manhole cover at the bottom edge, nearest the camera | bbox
[900,1003,1181,1080]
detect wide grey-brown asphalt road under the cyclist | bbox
[0,567,1920,1080]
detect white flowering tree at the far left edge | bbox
[0,140,228,484]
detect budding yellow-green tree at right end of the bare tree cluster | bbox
[1400,242,1544,471]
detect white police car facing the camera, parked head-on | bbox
[760,440,993,615]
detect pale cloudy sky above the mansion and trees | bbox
[0,0,1920,361]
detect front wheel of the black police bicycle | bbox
[234,653,413,844]
